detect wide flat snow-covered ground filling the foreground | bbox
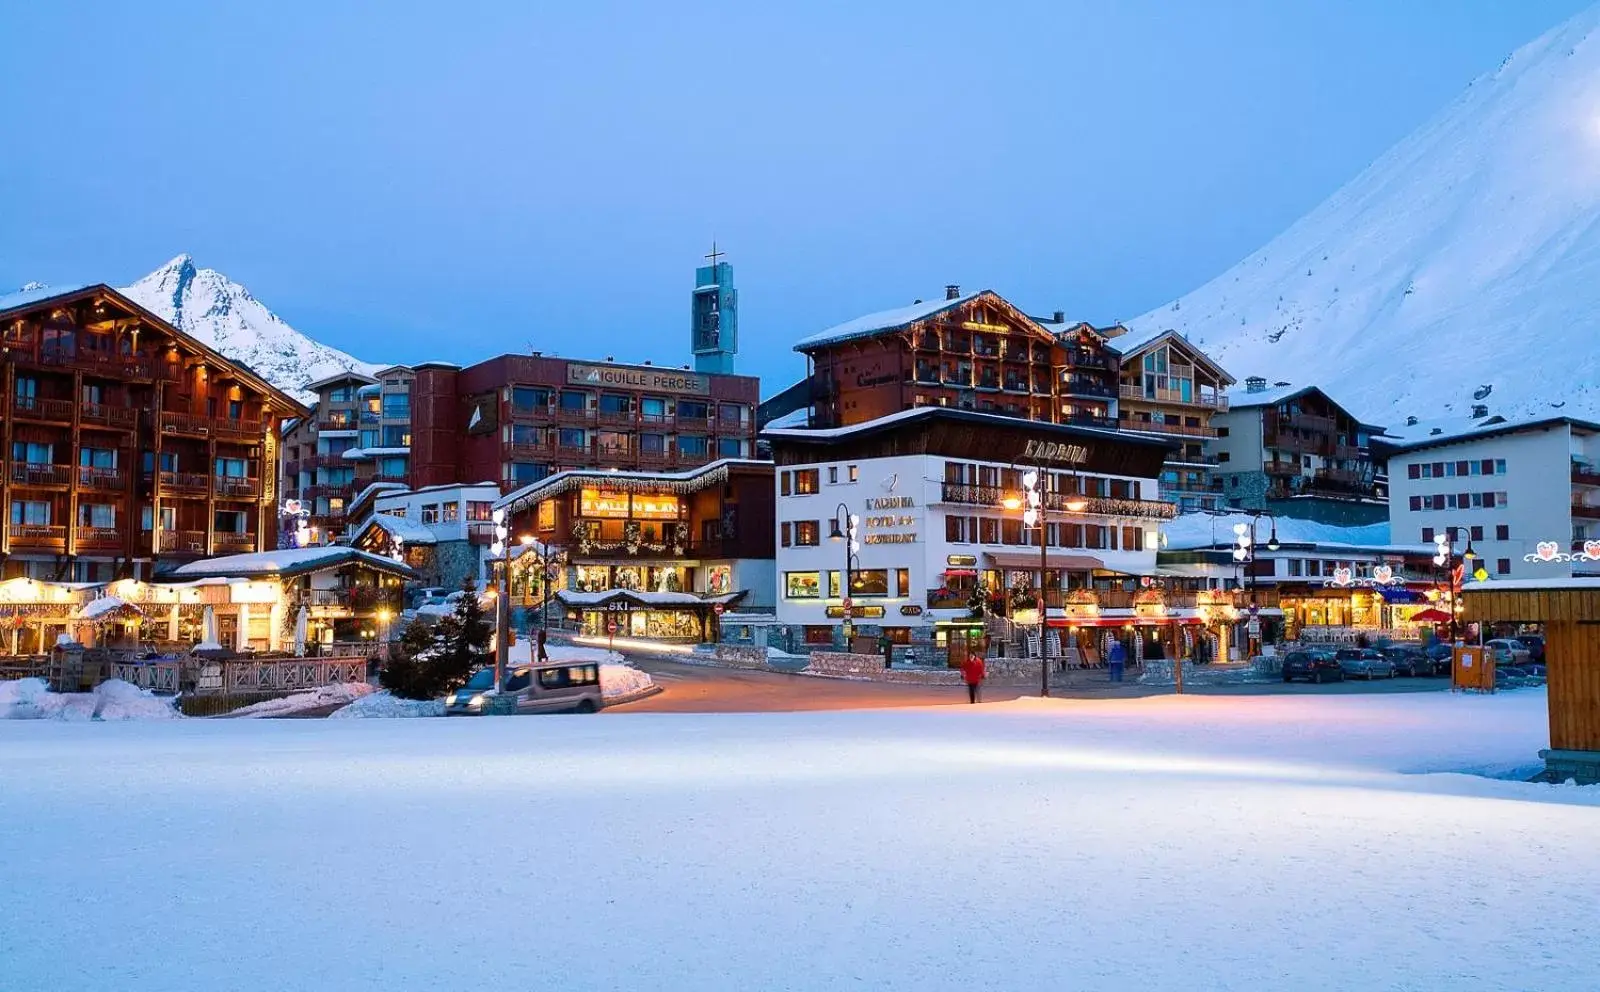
[0,691,1600,992]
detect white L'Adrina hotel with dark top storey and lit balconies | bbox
[763,406,1174,650]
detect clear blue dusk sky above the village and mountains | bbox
[0,0,1584,394]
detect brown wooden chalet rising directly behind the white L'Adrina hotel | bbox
[795,286,1117,429]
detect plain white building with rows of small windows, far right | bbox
[1384,416,1600,581]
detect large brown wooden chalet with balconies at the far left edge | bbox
[0,285,306,582]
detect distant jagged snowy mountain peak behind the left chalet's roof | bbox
[123,254,379,400]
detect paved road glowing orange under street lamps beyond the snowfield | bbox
[606,654,1450,714]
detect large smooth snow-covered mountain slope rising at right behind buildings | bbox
[1133,6,1600,424]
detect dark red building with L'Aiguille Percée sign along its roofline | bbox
[411,354,760,491]
